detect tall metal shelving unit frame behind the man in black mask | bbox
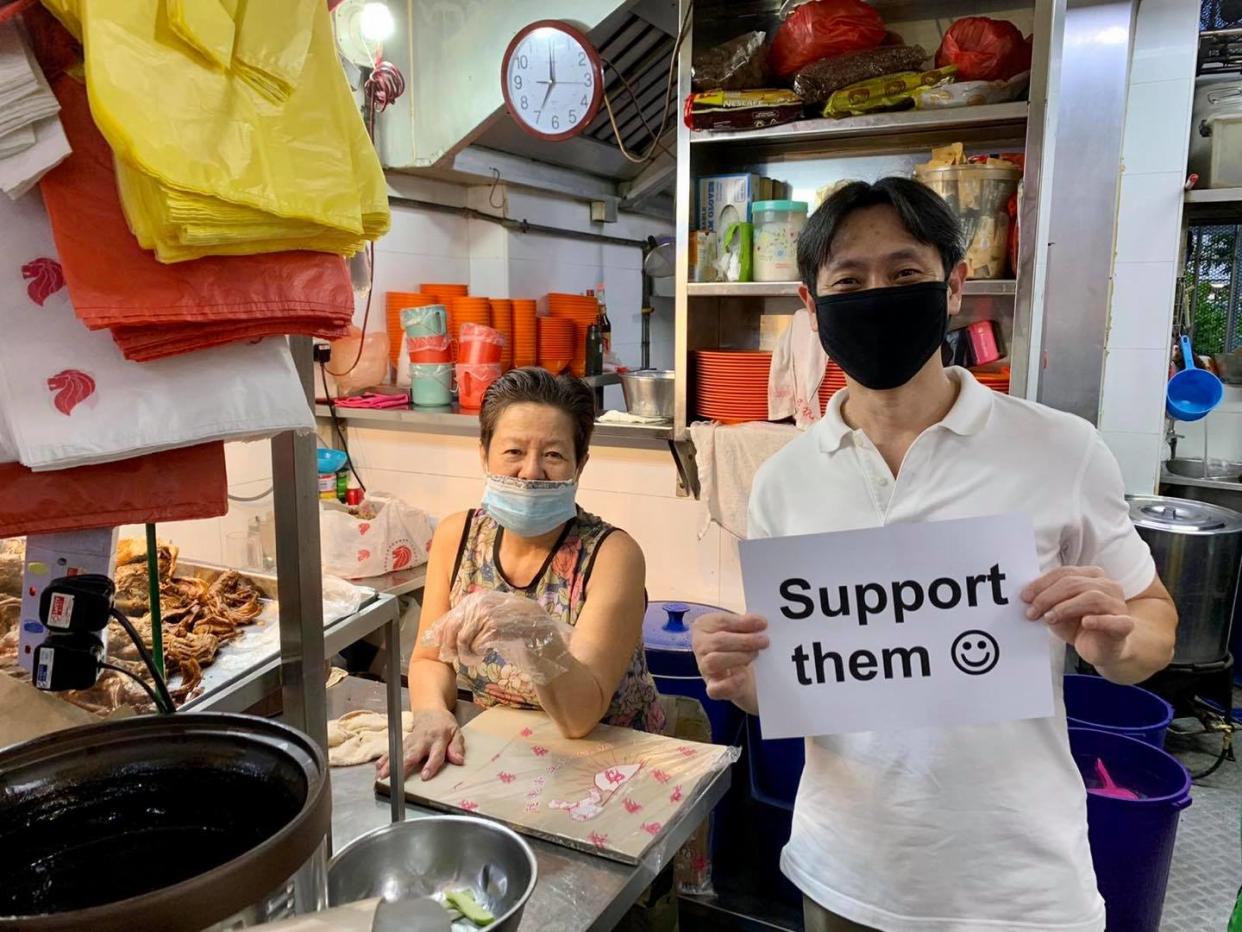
[672,0,1066,444]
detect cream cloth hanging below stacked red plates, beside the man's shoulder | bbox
[689,421,799,538]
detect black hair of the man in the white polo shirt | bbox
[797,176,966,296]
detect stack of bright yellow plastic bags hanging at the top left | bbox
[46,0,390,262]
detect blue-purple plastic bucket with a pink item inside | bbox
[1069,728,1190,932]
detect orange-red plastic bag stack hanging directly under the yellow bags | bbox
[41,75,354,360]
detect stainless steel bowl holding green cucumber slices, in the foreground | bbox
[328,815,539,932]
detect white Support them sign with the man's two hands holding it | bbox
[693,516,1167,738]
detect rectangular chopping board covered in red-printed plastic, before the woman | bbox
[375,707,734,864]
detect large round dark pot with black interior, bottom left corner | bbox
[0,713,332,932]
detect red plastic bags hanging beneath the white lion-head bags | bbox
[0,442,229,537]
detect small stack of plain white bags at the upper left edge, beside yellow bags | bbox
[0,20,70,199]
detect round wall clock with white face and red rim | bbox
[501,20,604,139]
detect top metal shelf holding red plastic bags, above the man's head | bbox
[691,102,1027,145]
